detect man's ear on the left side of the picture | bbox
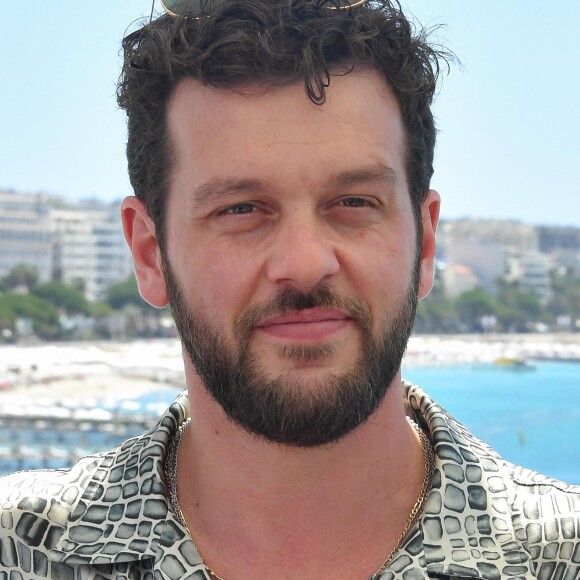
[121,196,168,308]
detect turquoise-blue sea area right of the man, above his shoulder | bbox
[403,362,580,484]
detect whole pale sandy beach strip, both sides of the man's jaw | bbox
[0,334,580,412]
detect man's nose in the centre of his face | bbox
[267,216,340,293]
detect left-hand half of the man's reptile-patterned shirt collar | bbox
[51,391,201,565]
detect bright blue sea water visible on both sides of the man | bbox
[0,362,580,484]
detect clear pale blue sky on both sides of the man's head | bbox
[0,0,580,227]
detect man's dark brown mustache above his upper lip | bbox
[234,284,372,339]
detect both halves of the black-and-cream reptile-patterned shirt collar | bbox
[51,382,527,578]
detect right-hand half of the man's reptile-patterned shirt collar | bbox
[404,382,528,578]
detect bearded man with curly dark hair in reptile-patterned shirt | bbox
[0,0,580,580]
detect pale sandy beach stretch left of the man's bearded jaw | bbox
[0,339,185,413]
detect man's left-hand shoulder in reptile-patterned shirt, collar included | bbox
[0,395,187,578]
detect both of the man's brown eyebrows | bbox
[192,163,399,205]
